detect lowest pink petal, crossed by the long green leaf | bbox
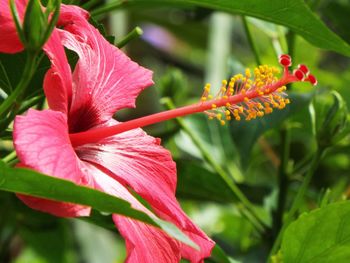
[85,163,181,263]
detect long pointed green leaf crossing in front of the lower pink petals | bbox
[0,162,198,249]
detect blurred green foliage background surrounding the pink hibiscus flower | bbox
[0,0,350,263]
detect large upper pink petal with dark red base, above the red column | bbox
[60,5,153,132]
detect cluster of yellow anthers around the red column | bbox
[201,65,290,125]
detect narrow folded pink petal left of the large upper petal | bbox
[44,29,72,114]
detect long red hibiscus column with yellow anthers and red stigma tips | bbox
[69,55,317,147]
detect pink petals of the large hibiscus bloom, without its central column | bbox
[8,2,214,263]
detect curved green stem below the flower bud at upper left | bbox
[0,52,36,117]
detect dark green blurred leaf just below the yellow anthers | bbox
[230,93,312,166]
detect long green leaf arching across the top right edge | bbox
[92,0,350,56]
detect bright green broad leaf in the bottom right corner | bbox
[282,201,350,263]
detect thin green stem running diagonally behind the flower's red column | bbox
[162,98,265,233]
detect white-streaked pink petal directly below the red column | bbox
[76,121,214,262]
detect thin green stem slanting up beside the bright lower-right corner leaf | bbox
[269,148,324,259]
